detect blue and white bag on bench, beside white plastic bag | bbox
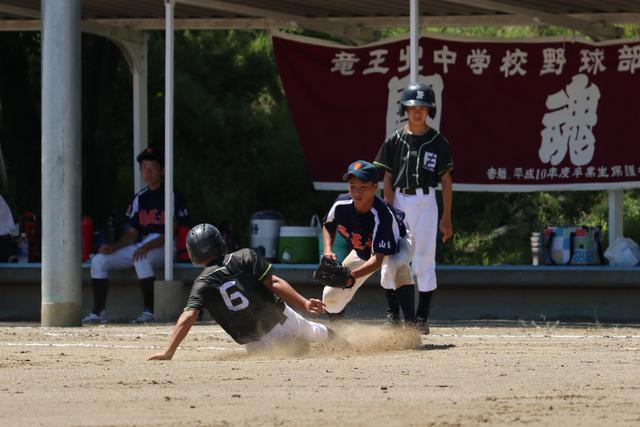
[542,226,604,265]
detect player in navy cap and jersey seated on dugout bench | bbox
[82,147,188,324]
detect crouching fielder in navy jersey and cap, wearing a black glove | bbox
[322,160,415,323]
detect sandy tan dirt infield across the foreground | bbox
[0,323,640,426]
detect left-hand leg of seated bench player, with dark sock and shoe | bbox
[82,245,135,323]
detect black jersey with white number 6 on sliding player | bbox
[185,249,286,344]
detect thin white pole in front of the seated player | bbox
[164,0,175,281]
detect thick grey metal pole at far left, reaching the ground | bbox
[41,0,82,326]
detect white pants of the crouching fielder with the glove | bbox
[322,232,414,313]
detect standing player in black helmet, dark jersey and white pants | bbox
[374,83,453,333]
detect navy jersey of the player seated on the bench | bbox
[127,184,189,236]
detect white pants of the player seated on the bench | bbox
[91,233,175,279]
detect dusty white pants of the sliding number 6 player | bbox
[244,304,329,353]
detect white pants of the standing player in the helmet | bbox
[393,187,438,292]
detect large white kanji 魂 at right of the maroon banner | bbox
[538,74,600,166]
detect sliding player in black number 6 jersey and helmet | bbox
[149,224,336,360]
